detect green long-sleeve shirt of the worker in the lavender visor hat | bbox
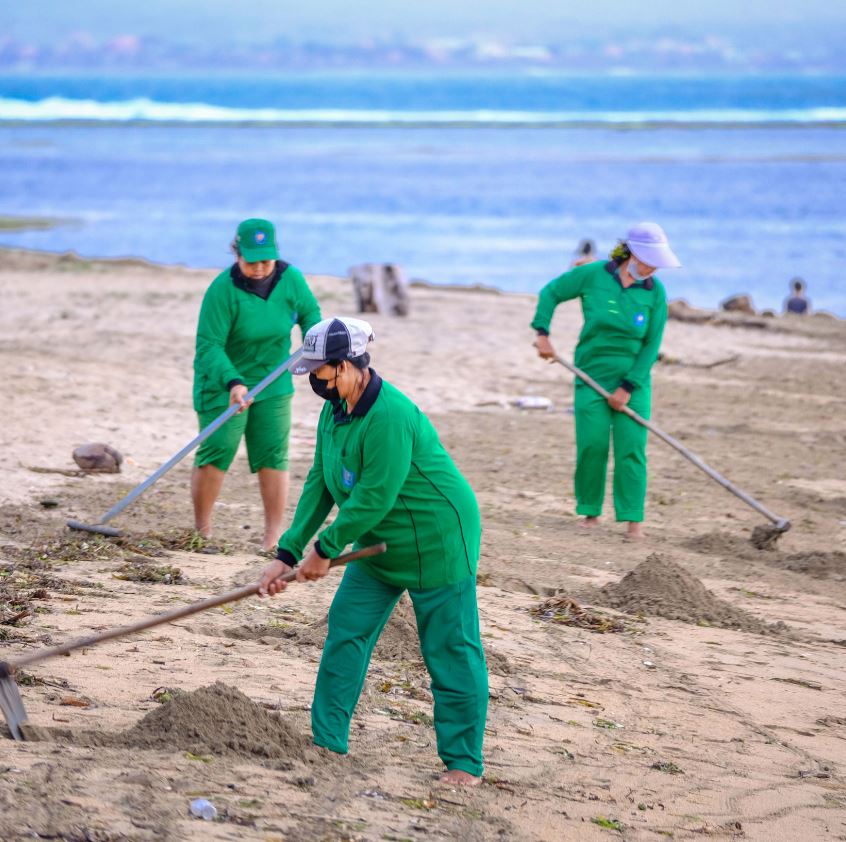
[532,261,667,392]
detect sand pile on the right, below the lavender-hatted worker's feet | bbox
[593,554,784,634]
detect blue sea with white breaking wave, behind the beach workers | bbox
[0,71,846,316]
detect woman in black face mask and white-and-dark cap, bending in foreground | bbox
[261,318,488,785]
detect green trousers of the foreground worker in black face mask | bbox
[311,563,488,775]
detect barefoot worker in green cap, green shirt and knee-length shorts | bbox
[191,219,320,552]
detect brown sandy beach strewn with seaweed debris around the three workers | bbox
[0,244,846,842]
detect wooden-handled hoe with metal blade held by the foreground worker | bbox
[0,544,387,740]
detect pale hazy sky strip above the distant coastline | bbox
[3,0,846,48]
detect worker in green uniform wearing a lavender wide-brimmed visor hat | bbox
[532,222,681,539]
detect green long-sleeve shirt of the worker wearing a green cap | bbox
[194,264,320,412]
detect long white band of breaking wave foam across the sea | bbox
[0,97,846,126]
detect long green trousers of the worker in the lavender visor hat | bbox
[574,383,652,522]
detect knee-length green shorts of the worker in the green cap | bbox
[194,395,293,473]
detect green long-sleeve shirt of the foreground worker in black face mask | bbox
[279,369,481,588]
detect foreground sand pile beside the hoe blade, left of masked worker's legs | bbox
[115,681,310,760]
